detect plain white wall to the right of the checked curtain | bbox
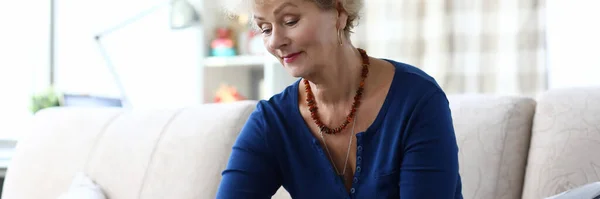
[547,0,600,88]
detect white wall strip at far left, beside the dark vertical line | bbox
[0,1,50,138]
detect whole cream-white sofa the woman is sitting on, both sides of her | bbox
[2,88,600,199]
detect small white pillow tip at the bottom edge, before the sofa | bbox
[58,173,106,199]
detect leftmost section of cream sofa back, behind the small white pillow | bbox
[2,108,119,199]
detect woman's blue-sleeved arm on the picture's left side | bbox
[216,103,281,199]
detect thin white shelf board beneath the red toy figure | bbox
[203,55,276,67]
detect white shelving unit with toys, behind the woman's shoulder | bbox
[200,0,296,103]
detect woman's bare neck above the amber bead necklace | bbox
[307,46,362,105]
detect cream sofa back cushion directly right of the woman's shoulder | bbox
[449,95,535,199]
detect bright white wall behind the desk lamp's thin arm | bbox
[56,0,203,108]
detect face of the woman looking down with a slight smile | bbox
[253,0,340,77]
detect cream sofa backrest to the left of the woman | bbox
[2,101,290,199]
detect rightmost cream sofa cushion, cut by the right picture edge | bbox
[523,88,600,199]
